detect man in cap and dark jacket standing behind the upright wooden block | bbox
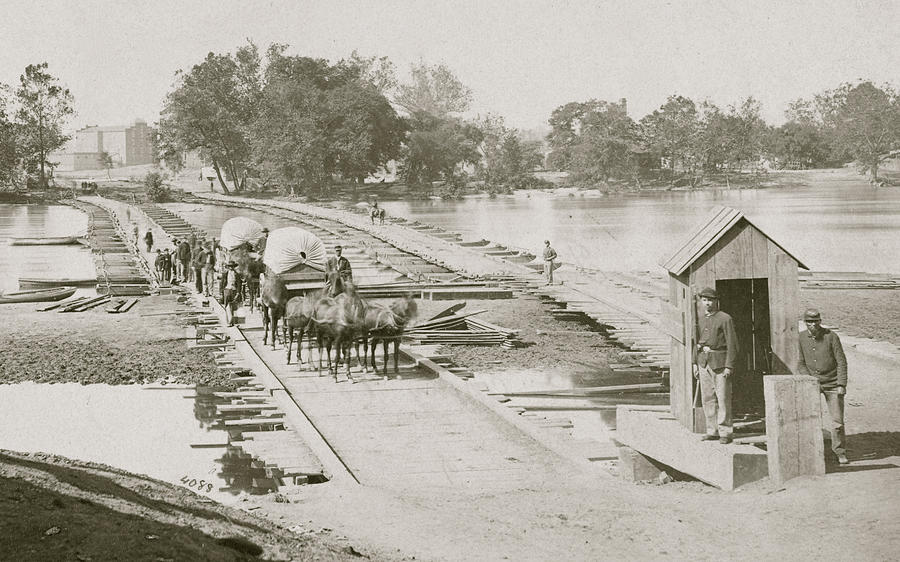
[797,308,850,464]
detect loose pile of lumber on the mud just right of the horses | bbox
[405,310,525,348]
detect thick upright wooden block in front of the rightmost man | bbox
[763,375,825,484]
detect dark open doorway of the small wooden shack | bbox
[716,278,771,417]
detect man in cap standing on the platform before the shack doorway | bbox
[694,287,738,444]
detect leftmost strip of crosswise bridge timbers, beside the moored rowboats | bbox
[72,200,151,296]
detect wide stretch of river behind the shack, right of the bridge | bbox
[381,172,900,273]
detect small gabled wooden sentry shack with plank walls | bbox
[660,207,809,432]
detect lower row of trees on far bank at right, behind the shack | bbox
[547,81,900,185]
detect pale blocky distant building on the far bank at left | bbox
[72,119,156,170]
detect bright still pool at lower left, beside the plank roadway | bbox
[0,383,288,502]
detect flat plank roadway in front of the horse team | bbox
[244,328,567,489]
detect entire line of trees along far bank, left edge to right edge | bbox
[0,42,900,194]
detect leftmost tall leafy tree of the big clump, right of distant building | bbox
[160,43,262,192]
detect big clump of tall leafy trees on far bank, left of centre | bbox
[157,43,541,193]
